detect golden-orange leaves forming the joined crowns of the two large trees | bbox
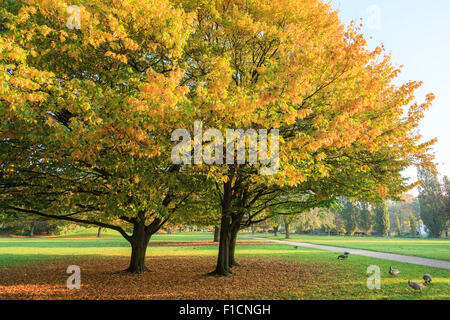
[0,0,433,228]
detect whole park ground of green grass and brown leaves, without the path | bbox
[0,229,450,300]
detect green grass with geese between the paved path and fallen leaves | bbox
[244,245,450,300]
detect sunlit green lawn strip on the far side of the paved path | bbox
[250,234,450,261]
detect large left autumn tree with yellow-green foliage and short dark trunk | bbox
[0,0,196,273]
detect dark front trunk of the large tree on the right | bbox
[210,181,232,276]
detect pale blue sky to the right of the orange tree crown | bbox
[330,0,450,182]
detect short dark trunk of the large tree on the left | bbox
[125,222,152,273]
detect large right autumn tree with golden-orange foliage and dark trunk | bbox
[174,0,433,275]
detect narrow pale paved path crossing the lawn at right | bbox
[241,236,450,270]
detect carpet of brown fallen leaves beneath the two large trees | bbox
[0,256,326,300]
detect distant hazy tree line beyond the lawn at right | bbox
[266,185,450,238]
